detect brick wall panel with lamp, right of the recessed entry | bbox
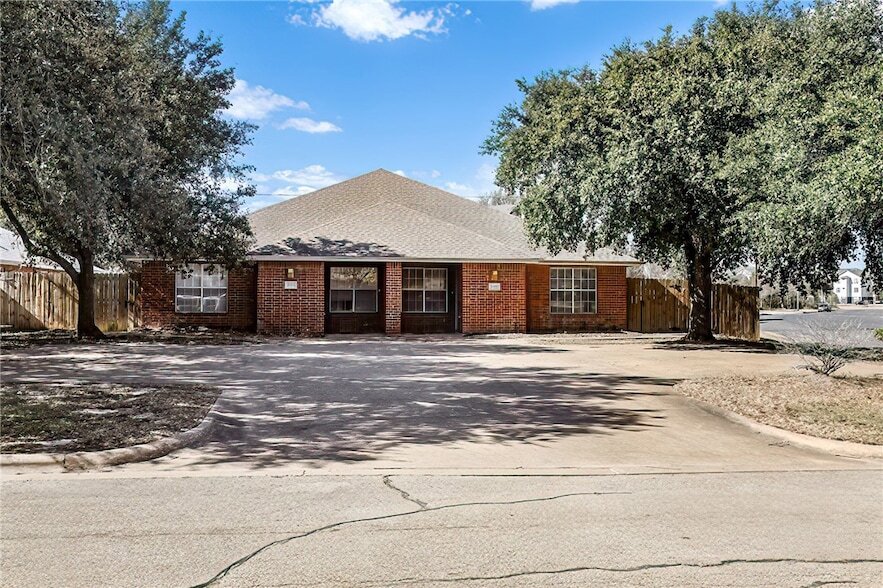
[461,263,527,334]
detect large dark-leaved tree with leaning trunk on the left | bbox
[0,0,253,336]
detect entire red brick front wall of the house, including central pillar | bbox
[141,261,627,335]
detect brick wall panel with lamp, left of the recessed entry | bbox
[257,261,325,336]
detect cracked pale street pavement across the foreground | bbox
[2,471,883,588]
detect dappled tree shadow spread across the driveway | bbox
[4,339,675,468]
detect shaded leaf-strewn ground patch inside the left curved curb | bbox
[0,383,220,453]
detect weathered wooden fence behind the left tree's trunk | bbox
[0,271,140,332]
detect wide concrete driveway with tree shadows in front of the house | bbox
[4,337,879,473]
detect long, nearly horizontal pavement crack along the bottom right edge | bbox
[385,557,883,588]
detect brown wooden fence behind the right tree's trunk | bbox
[628,278,760,341]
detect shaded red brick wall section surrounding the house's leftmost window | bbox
[141,261,255,331]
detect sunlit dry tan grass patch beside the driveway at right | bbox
[675,375,883,445]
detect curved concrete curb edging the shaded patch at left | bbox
[0,392,223,471]
